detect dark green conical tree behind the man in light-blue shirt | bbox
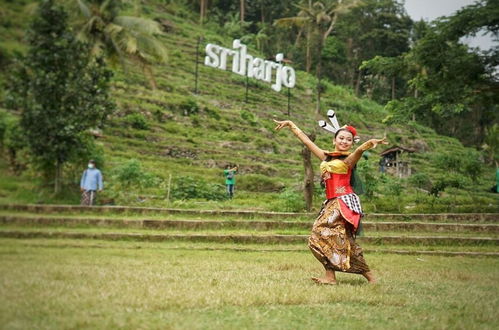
[7,0,114,193]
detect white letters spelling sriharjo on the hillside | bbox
[204,39,296,92]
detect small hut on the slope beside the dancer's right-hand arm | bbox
[379,146,414,178]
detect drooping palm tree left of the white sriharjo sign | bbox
[75,0,167,89]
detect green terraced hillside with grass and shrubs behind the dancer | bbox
[0,0,499,213]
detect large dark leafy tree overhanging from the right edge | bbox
[380,0,499,146]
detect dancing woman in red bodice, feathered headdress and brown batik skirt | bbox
[274,110,388,284]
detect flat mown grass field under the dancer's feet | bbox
[0,239,499,329]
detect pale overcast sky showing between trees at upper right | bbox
[399,0,497,50]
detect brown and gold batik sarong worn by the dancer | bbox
[308,198,369,274]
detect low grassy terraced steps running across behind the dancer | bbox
[0,204,499,257]
